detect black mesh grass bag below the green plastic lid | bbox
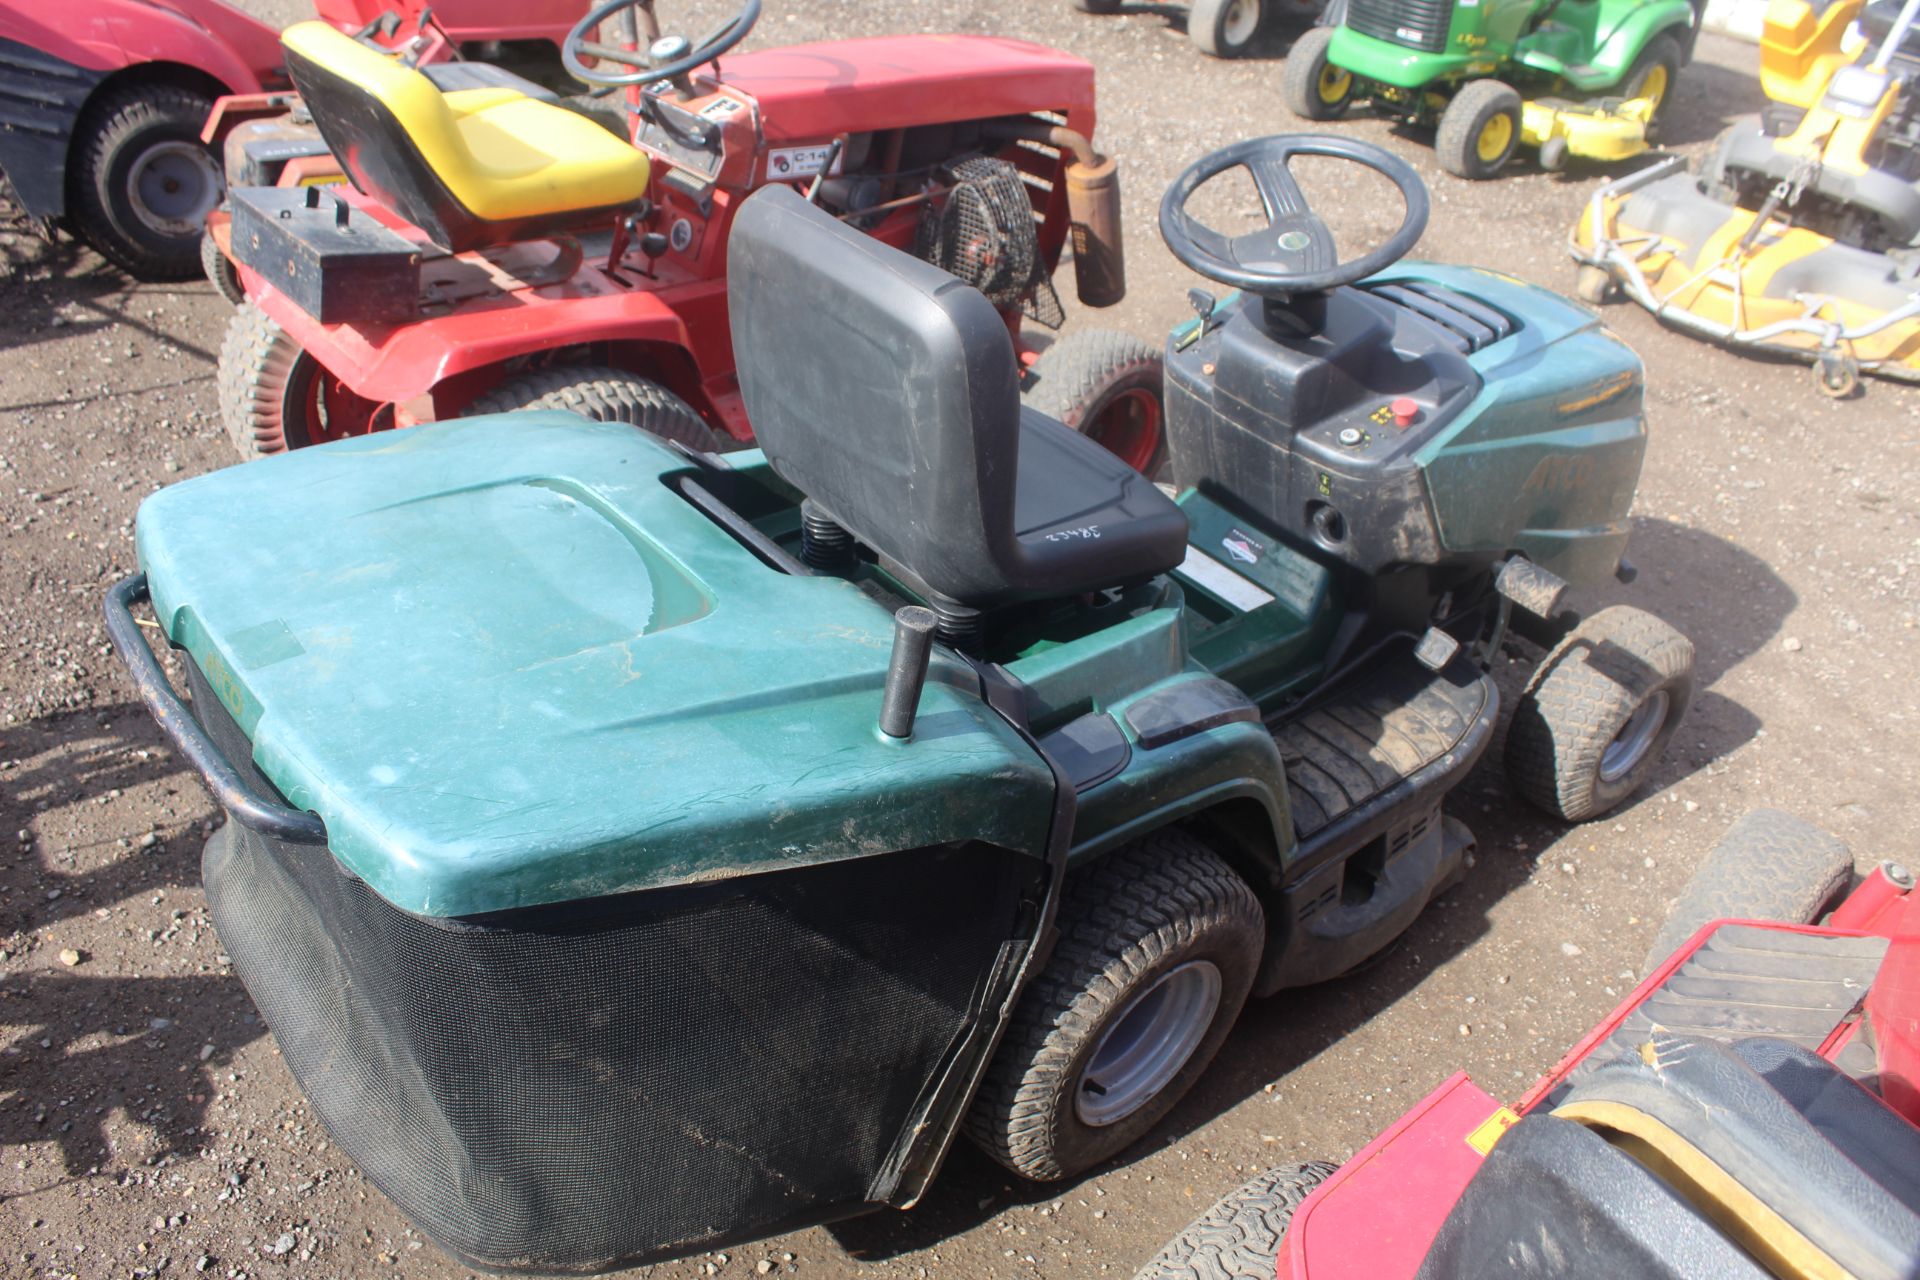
[190,664,1044,1272]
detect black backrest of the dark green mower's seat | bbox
[728,184,1021,603]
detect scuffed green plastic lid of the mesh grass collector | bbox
[136,413,1054,917]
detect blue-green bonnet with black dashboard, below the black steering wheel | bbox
[1167,261,1645,583]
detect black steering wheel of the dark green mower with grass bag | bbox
[1160,132,1428,299]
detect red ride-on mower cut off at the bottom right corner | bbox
[1135,810,1920,1280]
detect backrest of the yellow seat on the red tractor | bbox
[280,23,470,248]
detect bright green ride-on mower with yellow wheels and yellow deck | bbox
[1283,0,1699,178]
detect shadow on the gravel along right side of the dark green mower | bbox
[829,518,1797,1261]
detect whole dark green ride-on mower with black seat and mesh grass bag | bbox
[108,138,1692,1272]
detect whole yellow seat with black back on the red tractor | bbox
[280,23,647,253]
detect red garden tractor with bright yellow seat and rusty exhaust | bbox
[209,0,1165,472]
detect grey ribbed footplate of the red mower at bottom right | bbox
[1563,925,1887,1088]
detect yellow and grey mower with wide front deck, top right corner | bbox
[1571,0,1920,395]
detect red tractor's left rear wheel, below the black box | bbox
[219,301,380,459]
